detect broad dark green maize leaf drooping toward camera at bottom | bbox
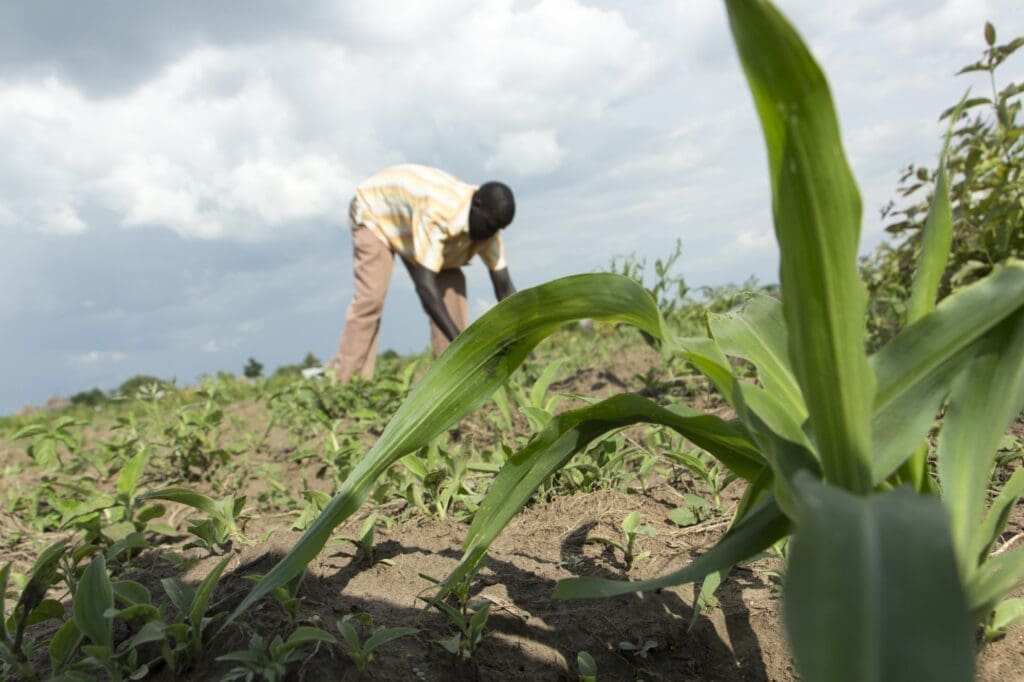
[784,475,974,682]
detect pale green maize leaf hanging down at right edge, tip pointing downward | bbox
[938,310,1024,576]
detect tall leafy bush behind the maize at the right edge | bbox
[861,24,1024,347]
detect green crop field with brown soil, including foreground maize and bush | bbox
[0,0,1024,680]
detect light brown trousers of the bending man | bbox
[332,224,469,381]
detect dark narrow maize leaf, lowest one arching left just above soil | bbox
[553,497,790,599]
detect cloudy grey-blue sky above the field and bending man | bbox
[0,0,1024,413]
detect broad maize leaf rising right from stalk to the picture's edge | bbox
[871,260,1024,483]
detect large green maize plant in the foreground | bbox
[239,0,1024,680]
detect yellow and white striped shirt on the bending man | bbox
[349,164,506,272]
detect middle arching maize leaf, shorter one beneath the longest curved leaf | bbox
[434,394,765,600]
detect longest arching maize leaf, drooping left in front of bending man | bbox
[227,274,665,623]
